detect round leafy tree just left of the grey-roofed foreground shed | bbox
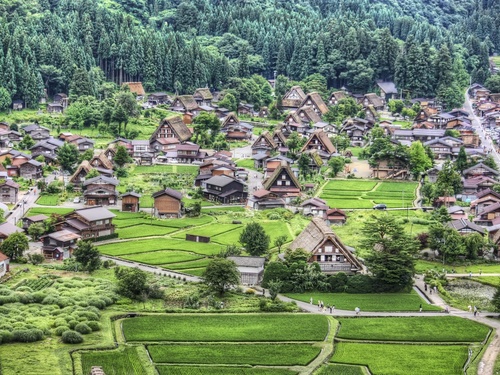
[203,258,240,295]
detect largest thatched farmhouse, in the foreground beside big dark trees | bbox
[289,217,363,274]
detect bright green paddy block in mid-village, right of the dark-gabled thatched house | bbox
[320,180,417,209]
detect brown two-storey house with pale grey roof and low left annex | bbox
[61,207,116,240]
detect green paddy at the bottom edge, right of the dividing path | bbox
[331,343,467,375]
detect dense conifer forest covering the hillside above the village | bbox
[0,0,500,107]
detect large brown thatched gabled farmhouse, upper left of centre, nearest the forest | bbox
[149,116,192,152]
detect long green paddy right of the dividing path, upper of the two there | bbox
[337,316,489,342]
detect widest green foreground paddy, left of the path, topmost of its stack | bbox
[122,314,328,342]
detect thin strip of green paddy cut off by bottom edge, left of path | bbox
[156,366,296,375]
